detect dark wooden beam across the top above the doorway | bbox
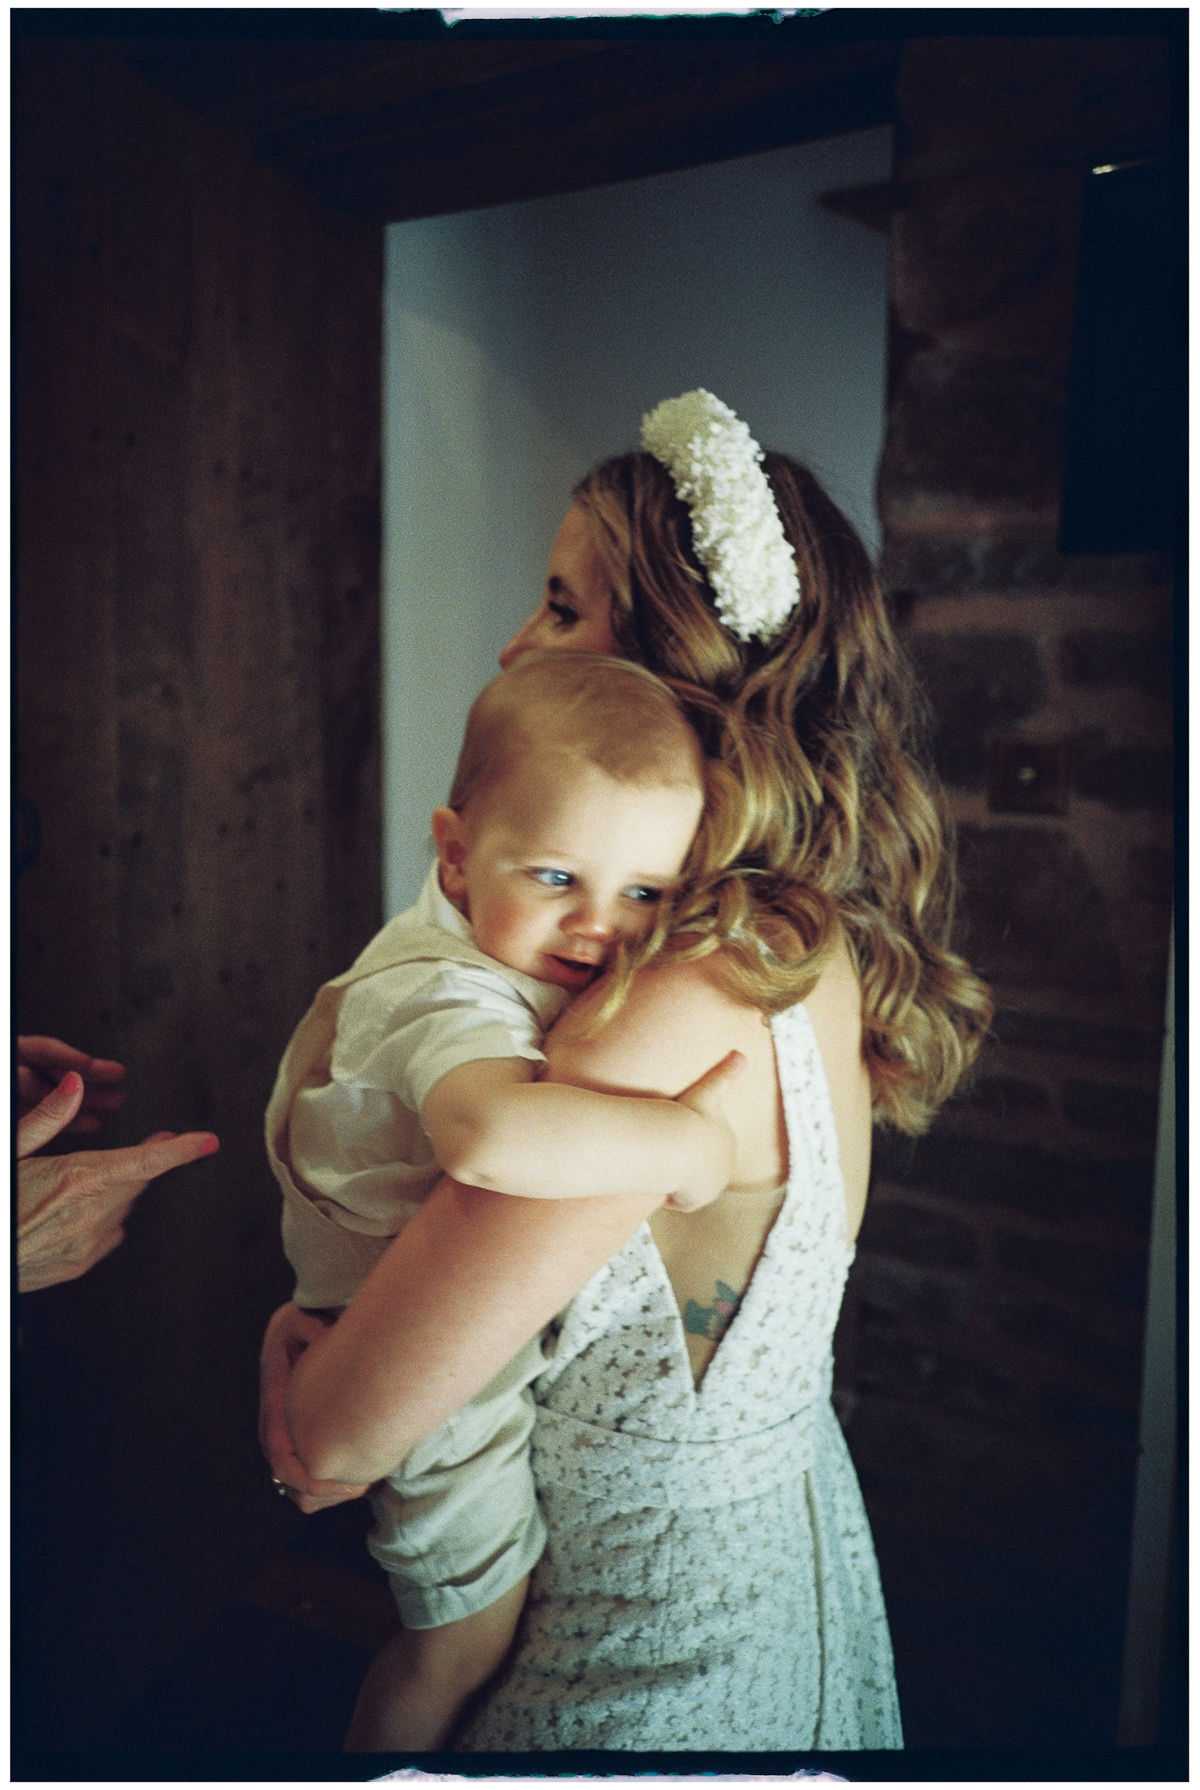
[122,21,901,222]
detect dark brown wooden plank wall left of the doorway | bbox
[14,39,381,1745]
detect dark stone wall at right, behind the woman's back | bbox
[840,36,1171,1745]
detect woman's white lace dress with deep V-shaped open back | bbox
[459,1008,903,1752]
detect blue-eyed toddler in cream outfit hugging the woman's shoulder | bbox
[267,650,736,1752]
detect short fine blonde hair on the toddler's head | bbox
[450,648,704,813]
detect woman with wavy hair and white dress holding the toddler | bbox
[263,392,990,1752]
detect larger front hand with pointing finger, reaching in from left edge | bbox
[16,1066,220,1292]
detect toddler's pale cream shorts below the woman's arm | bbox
[367,1337,546,1629]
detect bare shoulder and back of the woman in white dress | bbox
[548,947,870,1384]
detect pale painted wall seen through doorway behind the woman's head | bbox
[383,129,892,913]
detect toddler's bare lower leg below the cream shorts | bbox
[344,1577,528,1752]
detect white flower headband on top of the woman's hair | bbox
[641,390,801,641]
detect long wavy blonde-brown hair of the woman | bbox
[573,453,992,1135]
